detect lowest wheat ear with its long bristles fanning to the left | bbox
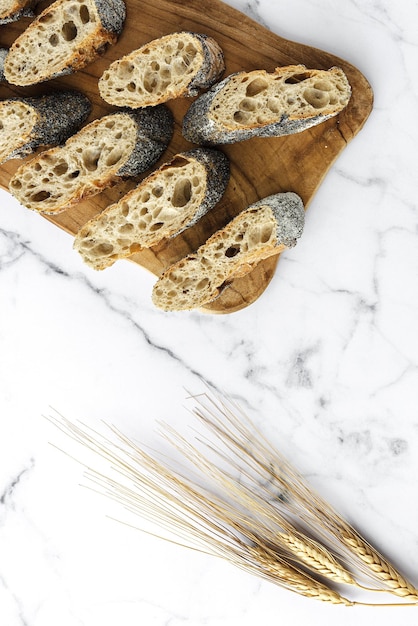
[50,416,352,606]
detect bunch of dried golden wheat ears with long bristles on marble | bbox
[49,393,418,606]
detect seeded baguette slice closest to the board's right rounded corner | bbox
[183,65,351,145]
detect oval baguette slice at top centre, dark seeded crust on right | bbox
[99,32,225,109]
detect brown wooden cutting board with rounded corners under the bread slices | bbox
[0,0,373,313]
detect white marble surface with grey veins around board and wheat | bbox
[0,0,418,626]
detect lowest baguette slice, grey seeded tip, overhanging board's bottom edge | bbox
[152,192,305,311]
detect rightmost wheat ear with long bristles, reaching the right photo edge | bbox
[189,394,418,603]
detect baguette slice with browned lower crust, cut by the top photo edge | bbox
[4,0,126,86]
